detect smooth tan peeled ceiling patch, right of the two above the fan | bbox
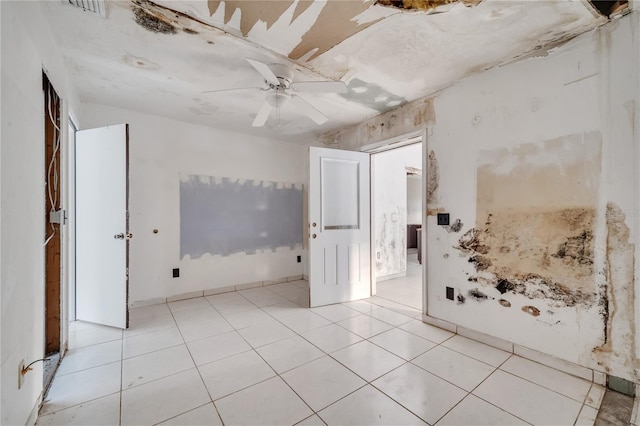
[290,0,383,61]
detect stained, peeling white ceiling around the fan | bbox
[42,0,606,143]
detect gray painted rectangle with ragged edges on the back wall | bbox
[180,175,303,259]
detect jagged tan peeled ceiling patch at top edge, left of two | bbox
[207,0,294,37]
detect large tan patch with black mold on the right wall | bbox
[456,133,601,317]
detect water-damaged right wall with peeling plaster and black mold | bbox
[426,12,640,382]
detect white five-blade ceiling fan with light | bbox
[202,58,347,127]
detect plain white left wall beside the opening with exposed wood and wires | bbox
[0,1,77,425]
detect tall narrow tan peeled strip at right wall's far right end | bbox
[594,202,637,372]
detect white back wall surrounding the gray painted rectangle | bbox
[78,104,307,305]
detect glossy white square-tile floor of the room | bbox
[36,281,604,425]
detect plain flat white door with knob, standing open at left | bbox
[76,124,130,328]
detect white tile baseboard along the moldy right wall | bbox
[422,315,608,384]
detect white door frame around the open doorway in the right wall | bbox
[359,129,427,315]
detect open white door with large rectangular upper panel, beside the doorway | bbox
[309,147,371,307]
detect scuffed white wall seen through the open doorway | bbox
[371,144,422,279]
